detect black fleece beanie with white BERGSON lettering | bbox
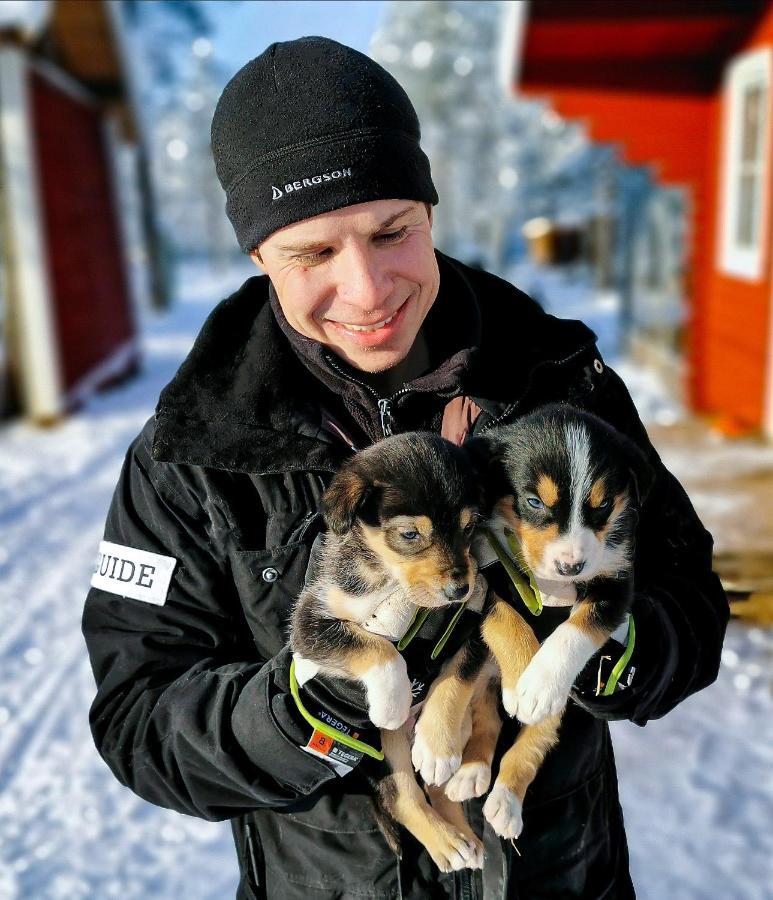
[212,37,438,253]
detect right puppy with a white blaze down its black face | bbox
[412,405,652,838]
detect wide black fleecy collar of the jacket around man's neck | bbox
[153,252,595,473]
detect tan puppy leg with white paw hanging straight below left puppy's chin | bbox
[412,635,488,784]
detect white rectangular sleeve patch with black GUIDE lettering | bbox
[91,541,177,606]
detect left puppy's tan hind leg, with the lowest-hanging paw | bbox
[377,726,483,872]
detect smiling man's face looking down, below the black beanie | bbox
[251,200,440,372]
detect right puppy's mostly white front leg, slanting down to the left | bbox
[508,579,630,725]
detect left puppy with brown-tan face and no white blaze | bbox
[290,433,482,871]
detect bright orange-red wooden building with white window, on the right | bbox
[514,0,773,435]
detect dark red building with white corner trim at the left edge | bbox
[0,0,146,423]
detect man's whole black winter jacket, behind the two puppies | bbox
[83,254,728,900]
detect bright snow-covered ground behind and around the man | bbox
[0,264,773,900]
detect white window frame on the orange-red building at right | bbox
[718,47,773,281]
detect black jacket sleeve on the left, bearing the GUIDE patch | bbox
[83,429,336,819]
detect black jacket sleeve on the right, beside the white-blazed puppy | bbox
[574,358,729,725]
